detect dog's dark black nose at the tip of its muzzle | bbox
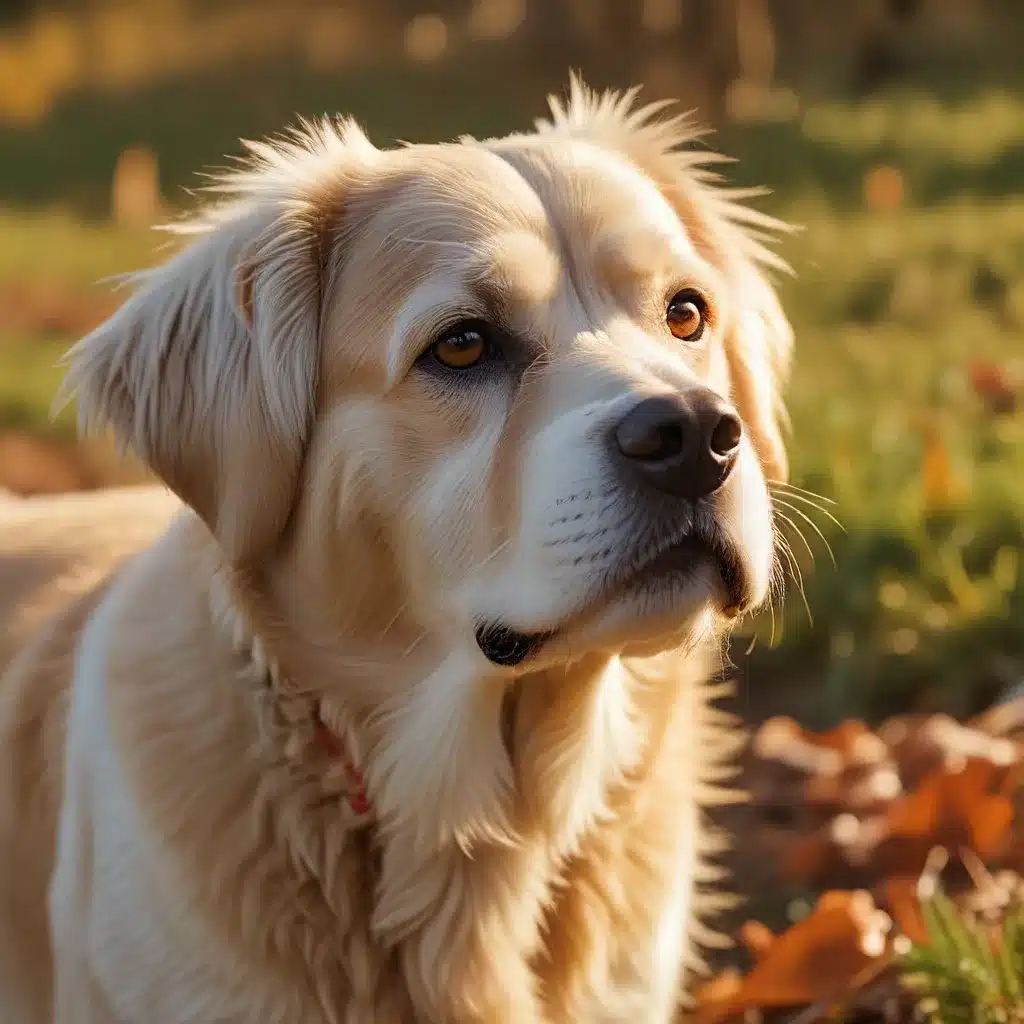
[614,388,743,501]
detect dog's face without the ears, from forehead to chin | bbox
[311,137,772,665]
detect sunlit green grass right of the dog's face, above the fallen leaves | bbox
[751,201,1024,719]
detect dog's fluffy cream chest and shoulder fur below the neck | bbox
[39,524,737,1022]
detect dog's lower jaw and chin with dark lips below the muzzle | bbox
[475,539,753,670]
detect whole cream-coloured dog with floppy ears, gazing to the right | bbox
[0,83,790,1024]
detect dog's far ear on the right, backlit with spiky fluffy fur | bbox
[537,77,793,480]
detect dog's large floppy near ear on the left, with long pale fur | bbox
[63,124,370,563]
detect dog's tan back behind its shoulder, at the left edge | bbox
[0,487,178,1024]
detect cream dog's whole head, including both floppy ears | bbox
[61,77,790,674]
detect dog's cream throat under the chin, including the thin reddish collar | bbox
[211,557,712,934]
